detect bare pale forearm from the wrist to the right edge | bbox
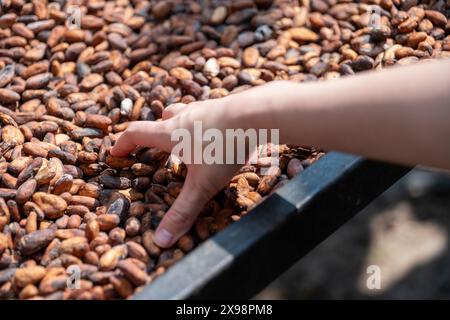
[225,61,450,169]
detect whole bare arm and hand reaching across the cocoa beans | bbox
[111,60,450,248]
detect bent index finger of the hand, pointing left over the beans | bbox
[111,121,171,157]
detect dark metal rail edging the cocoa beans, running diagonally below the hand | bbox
[133,152,410,299]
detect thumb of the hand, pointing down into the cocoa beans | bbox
[155,178,209,248]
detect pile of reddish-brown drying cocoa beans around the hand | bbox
[0,0,450,299]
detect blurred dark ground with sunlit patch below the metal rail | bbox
[255,169,450,299]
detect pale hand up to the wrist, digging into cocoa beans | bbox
[111,98,240,248]
